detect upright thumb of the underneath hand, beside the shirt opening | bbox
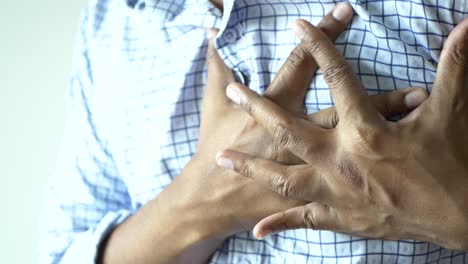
[204,29,235,108]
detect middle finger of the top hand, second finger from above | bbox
[226,83,331,162]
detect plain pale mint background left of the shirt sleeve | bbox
[0,0,87,264]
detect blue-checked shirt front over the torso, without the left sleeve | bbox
[82,0,468,263]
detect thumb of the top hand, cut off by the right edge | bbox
[431,18,468,111]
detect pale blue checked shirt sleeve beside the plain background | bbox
[39,5,133,264]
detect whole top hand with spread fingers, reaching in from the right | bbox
[218,15,468,251]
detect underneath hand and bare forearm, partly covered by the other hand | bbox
[100,2,427,264]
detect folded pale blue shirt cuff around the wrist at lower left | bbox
[60,210,131,264]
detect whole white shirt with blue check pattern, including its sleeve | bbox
[39,0,468,263]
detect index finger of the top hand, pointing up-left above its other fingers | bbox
[295,20,382,125]
